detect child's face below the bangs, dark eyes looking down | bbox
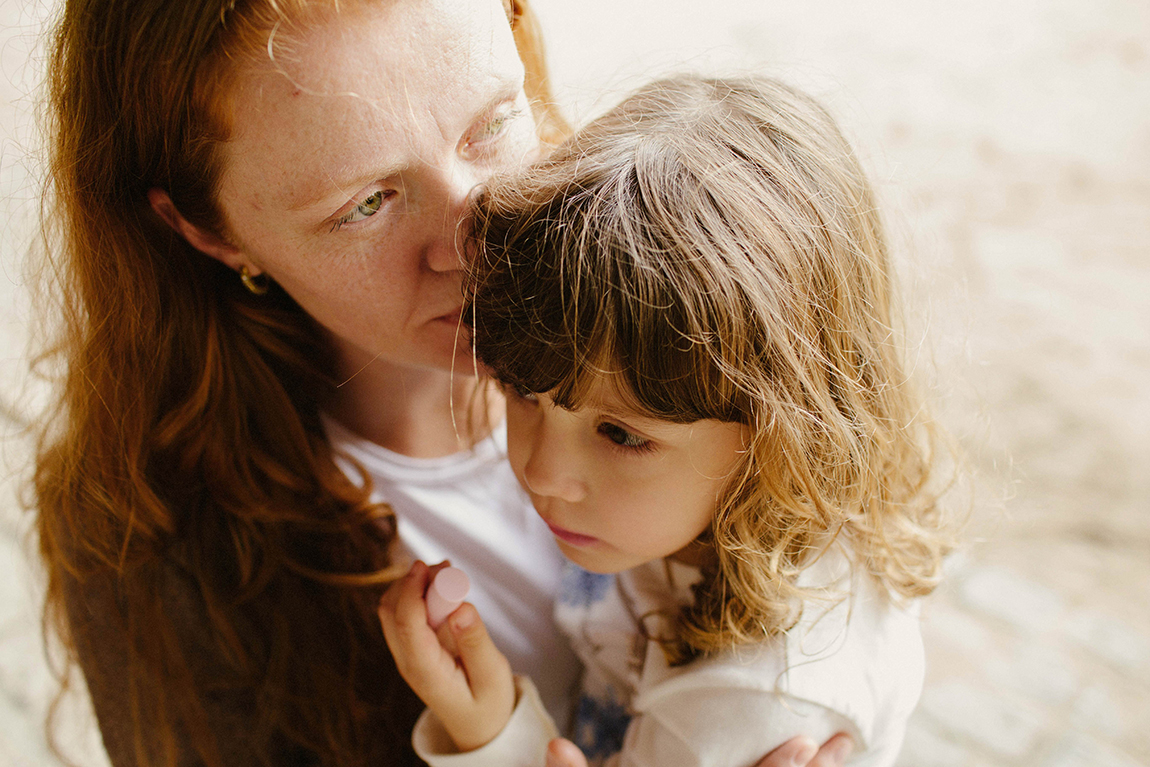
[507,378,745,573]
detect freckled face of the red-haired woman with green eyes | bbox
[220,0,537,377]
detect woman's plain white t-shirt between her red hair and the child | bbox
[324,419,580,722]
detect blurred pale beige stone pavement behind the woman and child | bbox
[0,0,1150,767]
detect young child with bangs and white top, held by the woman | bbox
[381,77,946,767]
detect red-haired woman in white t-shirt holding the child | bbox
[36,0,855,767]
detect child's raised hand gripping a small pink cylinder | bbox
[380,561,515,751]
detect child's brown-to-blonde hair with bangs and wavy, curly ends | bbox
[466,77,949,660]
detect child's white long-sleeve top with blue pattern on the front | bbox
[413,545,923,767]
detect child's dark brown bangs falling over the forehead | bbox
[470,179,746,423]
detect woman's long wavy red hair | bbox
[35,0,564,765]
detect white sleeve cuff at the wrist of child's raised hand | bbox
[412,675,559,767]
